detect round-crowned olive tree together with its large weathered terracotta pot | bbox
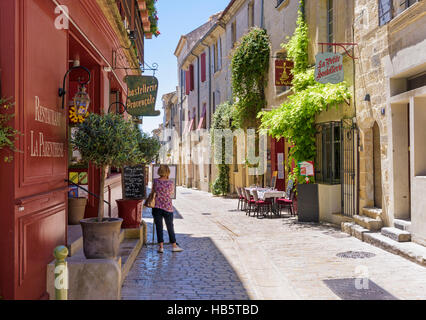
[72,114,140,259]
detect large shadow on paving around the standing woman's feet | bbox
[122,222,250,300]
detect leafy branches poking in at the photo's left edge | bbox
[0,98,21,162]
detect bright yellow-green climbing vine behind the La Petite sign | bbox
[258,1,351,183]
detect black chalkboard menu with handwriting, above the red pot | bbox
[123,165,146,200]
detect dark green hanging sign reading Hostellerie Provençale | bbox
[125,76,160,117]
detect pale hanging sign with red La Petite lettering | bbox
[315,52,344,84]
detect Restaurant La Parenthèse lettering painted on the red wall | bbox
[30,96,65,158]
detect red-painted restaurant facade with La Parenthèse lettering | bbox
[0,0,143,299]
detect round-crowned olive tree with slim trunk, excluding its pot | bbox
[72,113,142,222]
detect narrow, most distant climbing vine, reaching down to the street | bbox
[210,102,235,195]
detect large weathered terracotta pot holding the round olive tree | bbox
[80,218,123,259]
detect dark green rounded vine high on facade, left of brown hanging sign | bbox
[231,28,271,129]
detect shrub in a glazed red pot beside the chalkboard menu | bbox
[116,129,161,228]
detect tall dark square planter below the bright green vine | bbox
[297,184,319,222]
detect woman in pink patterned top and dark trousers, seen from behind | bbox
[152,165,183,253]
